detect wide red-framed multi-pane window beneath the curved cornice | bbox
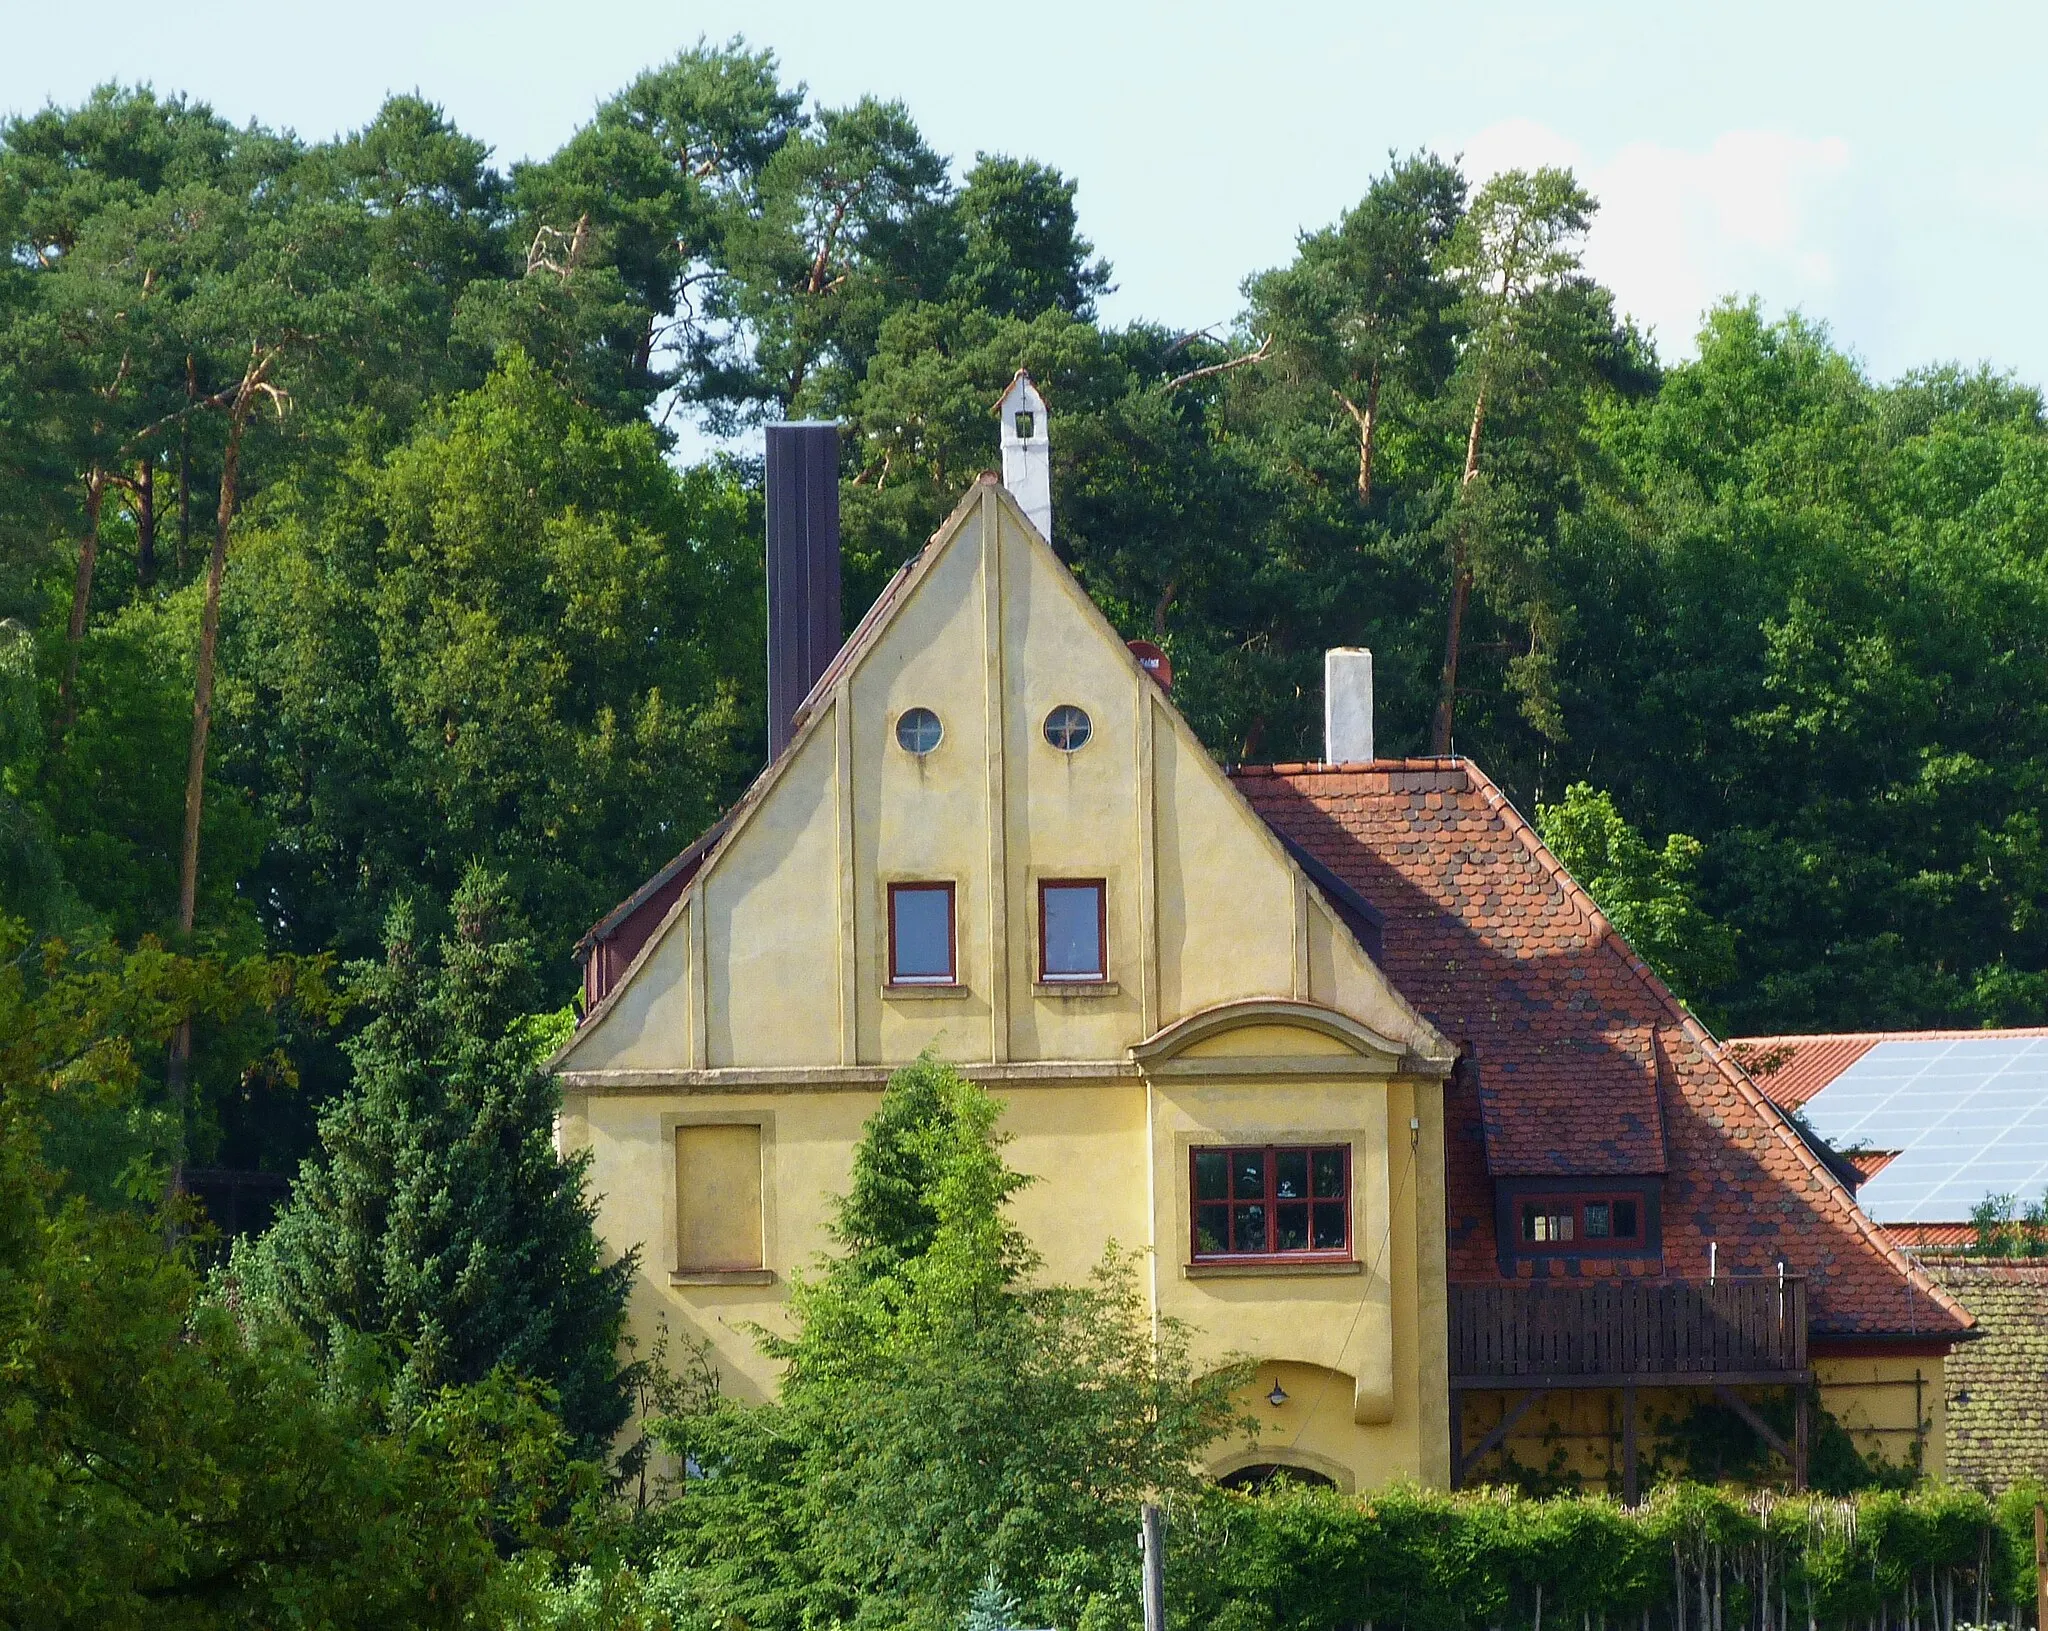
[1188,1143,1352,1262]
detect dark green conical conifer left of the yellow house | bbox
[238,867,637,1455]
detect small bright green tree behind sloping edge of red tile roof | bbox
[1536,781,1735,1002]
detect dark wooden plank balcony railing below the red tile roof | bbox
[1450,1277,1806,1387]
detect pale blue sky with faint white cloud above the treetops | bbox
[0,0,2048,383]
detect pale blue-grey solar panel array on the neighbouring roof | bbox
[1804,1035,2048,1223]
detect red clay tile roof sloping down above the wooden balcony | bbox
[1233,758,1970,1338]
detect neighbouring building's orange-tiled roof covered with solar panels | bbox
[1731,1029,2048,1225]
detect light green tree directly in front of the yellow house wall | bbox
[659,1059,1243,1627]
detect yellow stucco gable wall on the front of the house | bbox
[557,486,1450,1488]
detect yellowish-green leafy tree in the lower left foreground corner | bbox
[0,920,590,1631]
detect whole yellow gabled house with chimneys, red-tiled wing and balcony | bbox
[555,417,1970,1498]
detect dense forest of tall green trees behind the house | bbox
[0,41,2048,1196]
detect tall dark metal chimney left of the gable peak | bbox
[768,420,840,760]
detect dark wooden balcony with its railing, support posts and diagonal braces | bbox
[1450,1277,1808,1506]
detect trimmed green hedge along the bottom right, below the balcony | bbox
[1167,1483,2044,1631]
